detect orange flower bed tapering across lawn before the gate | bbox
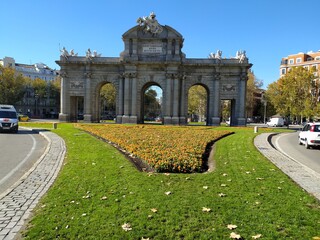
[76,124,232,173]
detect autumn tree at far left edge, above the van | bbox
[0,66,26,105]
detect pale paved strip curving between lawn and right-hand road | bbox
[254,133,320,200]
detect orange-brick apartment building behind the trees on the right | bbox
[280,50,320,77]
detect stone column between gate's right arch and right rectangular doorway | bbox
[209,73,221,126]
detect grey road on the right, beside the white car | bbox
[272,132,320,173]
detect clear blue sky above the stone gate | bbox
[0,0,320,88]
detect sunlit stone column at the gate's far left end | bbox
[59,71,70,122]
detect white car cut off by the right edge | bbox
[299,123,320,149]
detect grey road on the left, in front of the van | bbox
[0,128,47,195]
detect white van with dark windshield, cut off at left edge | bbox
[0,104,19,133]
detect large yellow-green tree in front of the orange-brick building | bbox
[267,67,319,120]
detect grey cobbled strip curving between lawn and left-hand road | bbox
[0,131,66,240]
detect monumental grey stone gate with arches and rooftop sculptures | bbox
[56,13,252,126]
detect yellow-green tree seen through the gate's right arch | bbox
[188,85,207,122]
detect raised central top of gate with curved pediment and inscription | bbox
[120,14,185,62]
